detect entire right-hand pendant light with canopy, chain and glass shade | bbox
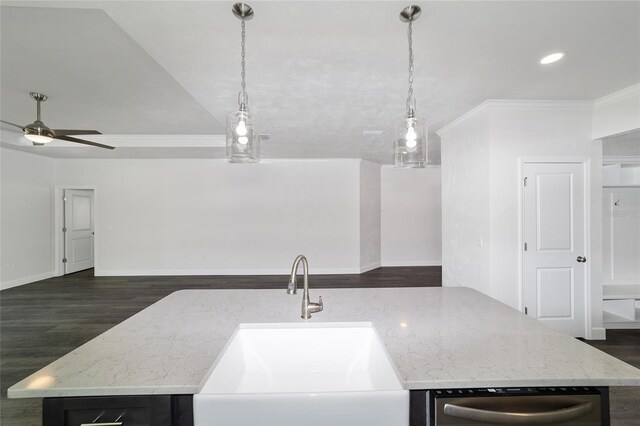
[395,5,427,168]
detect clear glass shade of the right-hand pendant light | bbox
[395,116,427,168]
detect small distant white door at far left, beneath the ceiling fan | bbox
[63,189,94,274]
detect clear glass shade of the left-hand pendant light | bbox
[227,110,260,163]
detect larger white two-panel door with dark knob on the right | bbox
[523,163,587,337]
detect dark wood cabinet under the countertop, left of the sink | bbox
[42,395,193,426]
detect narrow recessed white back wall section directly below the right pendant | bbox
[380,166,442,266]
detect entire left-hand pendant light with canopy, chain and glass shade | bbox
[227,3,260,163]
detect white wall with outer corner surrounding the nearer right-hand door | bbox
[439,101,602,333]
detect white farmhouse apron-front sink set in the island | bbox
[193,323,409,426]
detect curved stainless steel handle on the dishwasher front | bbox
[444,401,593,425]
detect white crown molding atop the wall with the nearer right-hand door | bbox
[436,99,593,136]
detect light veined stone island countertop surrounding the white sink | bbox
[8,288,640,398]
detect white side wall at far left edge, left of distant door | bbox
[0,148,54,289]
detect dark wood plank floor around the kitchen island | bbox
[0,267,640,426]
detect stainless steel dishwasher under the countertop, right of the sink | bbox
[418,387,609,426]
